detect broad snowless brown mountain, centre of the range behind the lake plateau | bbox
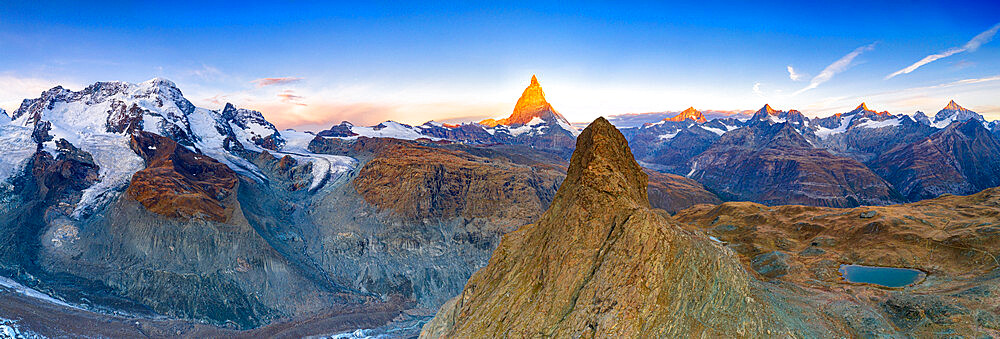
[689,123,902,207]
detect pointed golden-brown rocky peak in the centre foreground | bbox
[421,118,828,338]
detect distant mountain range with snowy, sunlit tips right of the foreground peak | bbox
[622,101,1000,207]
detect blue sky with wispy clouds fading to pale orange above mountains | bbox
[0,0,1000,130]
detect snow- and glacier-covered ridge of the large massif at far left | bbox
[0,79,356,218]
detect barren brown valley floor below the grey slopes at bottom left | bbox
[0,287,429,338]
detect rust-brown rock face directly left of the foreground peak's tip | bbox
[352,137,562,224]
